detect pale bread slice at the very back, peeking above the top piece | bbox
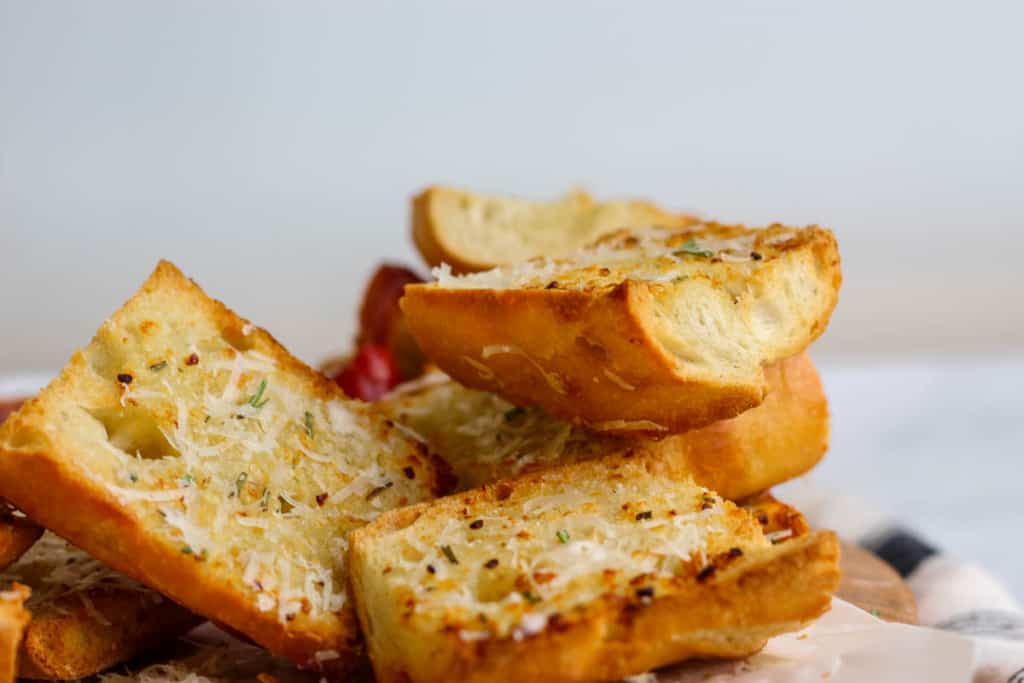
[413,185,698,272]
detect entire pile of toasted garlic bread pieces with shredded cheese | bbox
[0,186,841,683]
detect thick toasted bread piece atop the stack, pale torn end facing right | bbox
[401,224,842,435]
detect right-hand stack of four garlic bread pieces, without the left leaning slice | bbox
[349,188,842,683]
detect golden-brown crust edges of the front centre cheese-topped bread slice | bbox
[349,463,839,683]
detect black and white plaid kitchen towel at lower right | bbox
[781,481,1024,683]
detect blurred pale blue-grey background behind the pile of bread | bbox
[0,0,1024,596]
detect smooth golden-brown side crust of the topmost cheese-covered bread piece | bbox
[401,283,765,434]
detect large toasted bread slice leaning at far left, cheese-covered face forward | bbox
[0,262,439,676]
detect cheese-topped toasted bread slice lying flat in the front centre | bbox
[349,461,839,683]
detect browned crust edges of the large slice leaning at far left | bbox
[0,262,440,678]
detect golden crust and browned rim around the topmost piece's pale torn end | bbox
[401,228,842,435]
